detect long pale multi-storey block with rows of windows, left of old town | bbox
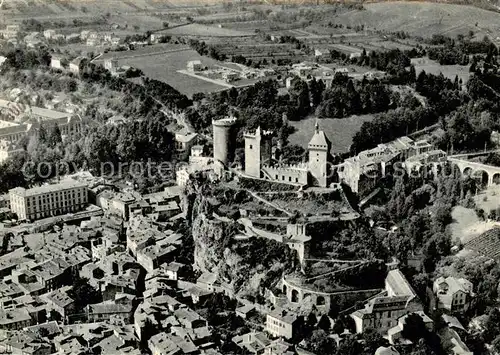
[9,181,88,220]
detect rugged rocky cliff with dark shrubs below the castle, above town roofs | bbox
[188,184,298,296]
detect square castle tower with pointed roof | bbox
[308,121,331,187]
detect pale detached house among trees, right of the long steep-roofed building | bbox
[432,276,474,312]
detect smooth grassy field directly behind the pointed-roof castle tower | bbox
[290,115,373,153]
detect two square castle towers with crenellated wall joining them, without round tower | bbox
[244,122,331,187]
